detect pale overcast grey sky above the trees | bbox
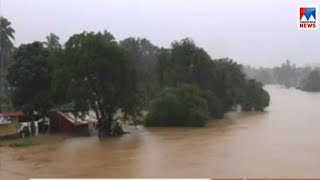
[0,0,320,66]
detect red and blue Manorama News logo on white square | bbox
[298,6,318,30]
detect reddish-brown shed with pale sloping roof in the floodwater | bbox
[49,111,98,136]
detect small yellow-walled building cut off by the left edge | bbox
[0,112,23,139]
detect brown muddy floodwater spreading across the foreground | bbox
[0,86,320,180]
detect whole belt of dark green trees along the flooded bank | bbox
[1,18,270,137]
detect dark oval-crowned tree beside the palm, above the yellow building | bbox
[7,42,52,134]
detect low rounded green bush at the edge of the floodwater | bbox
[145,85,209,126]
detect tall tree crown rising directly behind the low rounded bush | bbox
[158,38,216,89]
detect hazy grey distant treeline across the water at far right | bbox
[243,60,320,91]
